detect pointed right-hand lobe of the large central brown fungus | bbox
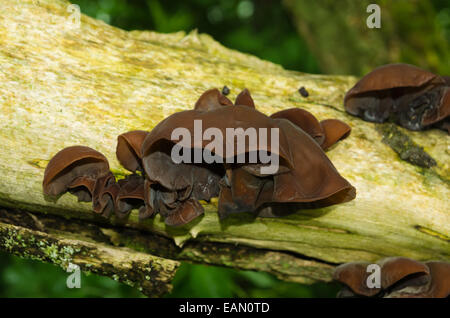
[219,119,356,218]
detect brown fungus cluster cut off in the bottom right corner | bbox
[333,257,450,298]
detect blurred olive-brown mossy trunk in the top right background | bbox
[283,0,450,75]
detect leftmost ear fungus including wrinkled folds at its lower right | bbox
[42,146,118,216]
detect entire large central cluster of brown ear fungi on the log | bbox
[43,89,355,226]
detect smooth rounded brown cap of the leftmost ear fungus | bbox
[42,146,109,198]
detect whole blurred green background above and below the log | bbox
[0,0,450,297]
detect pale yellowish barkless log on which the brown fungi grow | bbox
[0,0,450,288]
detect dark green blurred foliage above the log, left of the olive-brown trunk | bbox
[72,0,320,73]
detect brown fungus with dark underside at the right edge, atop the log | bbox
[344,64,450,133]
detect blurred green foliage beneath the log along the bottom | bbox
[0,252,339,298]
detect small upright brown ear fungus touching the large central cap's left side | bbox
[116,130,148,172]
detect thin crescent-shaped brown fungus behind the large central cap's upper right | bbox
[270,108,325,145]
